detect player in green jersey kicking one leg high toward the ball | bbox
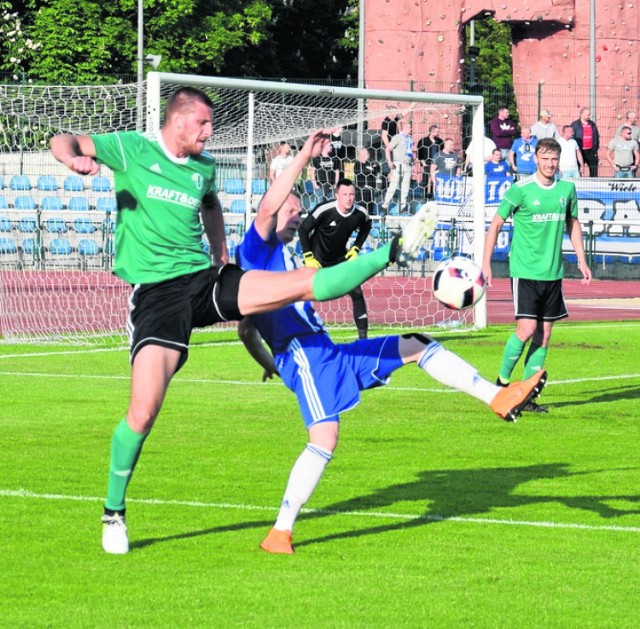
[51,87,435,554]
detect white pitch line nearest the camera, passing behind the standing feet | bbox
[0,489,640,533]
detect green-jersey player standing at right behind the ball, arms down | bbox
[482,138,591,412]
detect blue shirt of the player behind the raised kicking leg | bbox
[236,223,327,356]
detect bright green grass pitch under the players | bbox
[0,322,640,628]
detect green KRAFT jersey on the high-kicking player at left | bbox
[91,131,216,284]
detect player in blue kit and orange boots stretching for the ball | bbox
[238,134,546,554]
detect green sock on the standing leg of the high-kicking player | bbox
[104,419,149,511]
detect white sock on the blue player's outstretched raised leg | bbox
[418,341,500,404]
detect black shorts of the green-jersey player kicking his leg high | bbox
[127,264,245,371]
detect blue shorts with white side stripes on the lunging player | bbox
[276,334,403,428]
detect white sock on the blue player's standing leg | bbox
[275,443,333,531]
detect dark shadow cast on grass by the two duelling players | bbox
[131,463,640,549]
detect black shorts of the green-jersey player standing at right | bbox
[511,277,569,321]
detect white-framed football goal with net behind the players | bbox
[0,73,486,344]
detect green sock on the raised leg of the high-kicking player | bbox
[313,242,392,301]
